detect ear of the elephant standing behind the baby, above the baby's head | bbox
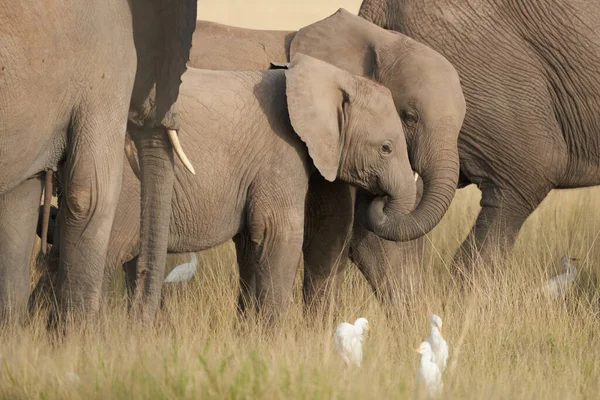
[290,8,392,77]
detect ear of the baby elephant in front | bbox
[285,53,356,182]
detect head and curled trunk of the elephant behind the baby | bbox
[290,9,466,241]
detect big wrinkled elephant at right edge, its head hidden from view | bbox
[359,0,600,272]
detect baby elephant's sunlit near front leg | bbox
[241,195,304,325]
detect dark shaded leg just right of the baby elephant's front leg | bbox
[302,174,356,314]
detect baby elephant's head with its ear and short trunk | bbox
[286,53,416,215]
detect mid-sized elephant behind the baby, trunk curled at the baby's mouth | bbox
[190,9,465,311]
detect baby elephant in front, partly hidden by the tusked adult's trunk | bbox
[35,54,416,317]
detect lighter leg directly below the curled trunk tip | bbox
[350,191,425,320]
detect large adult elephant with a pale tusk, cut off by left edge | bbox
[0,0,196,322]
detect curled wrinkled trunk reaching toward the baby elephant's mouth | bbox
[367,134,459,242]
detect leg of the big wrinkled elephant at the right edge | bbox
[453,185,550,277]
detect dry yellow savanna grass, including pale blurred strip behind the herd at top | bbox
[0,0,600,399]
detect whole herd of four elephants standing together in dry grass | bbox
[0,0,600,328]
